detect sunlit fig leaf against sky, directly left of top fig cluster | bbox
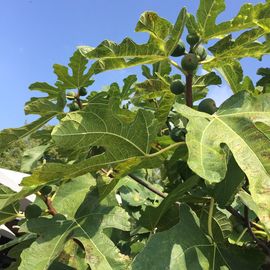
[79,9,186,74]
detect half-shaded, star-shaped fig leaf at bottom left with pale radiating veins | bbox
[18,184,130,270]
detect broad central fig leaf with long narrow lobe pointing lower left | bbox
[23,96,157,185]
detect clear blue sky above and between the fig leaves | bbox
[0,0,270,129]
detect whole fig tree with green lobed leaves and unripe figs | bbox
[0,0,270,270]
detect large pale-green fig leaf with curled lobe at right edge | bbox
[176,92,270,232]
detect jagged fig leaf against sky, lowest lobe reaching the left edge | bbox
[0,51,93,151]
